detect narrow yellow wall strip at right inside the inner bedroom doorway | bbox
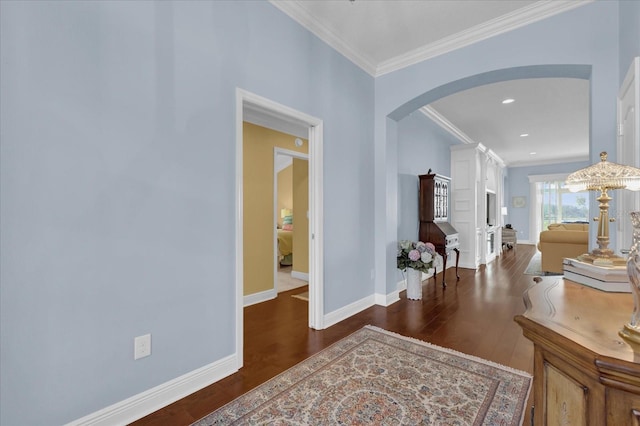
[291,158,309,274]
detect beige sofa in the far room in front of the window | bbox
[538,223,589,274]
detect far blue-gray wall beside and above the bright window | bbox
[505,161,591,243]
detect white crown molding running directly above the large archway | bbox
[375,0,595,77]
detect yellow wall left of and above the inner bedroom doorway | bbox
[243,122,309,296]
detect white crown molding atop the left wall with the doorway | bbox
[269,0,376,77]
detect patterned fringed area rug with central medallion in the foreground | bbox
[194,326,531,426]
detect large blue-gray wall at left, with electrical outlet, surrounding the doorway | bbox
[0,1,374,425]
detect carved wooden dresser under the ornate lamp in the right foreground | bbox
[515,277,640,426]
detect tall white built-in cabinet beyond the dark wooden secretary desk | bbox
[450,143,505,269]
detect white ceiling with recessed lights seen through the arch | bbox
[429,78,589,167]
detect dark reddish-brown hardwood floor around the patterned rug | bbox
[133,245,536,425]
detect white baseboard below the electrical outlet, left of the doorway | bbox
[67,354,238,426]
